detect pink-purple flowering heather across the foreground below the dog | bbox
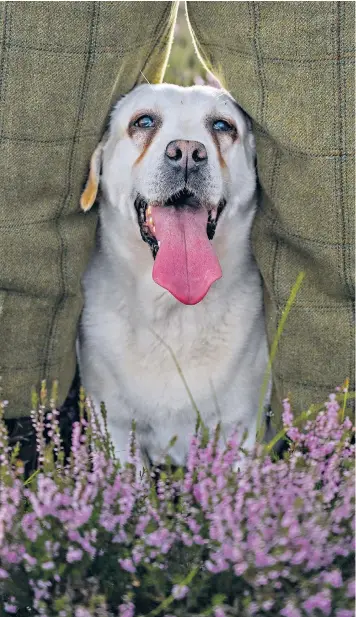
[0,384,355,617]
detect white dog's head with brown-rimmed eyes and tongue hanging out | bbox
[81,84,255,304]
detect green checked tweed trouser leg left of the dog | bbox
[0,1,177,418]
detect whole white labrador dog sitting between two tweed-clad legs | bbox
[78,84,267,465]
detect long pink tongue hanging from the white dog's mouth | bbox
[152,206,222,304]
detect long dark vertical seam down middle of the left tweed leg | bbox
[43,2,100,375]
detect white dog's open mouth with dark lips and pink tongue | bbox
[135,189,225,304]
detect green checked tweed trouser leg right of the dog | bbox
[187,2,355,425]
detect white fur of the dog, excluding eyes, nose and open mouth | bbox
[79,84,267,465]
